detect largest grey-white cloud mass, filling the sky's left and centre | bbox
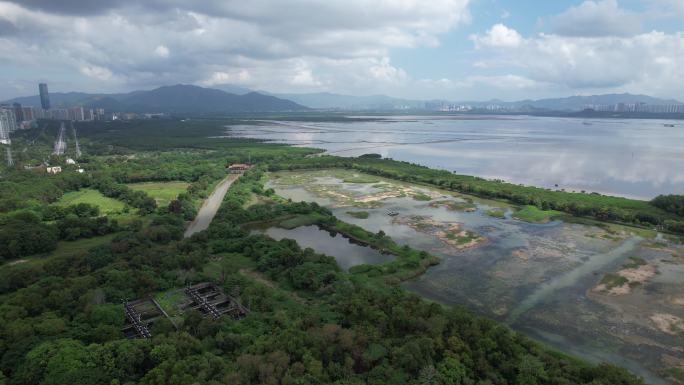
[0,0,470,92]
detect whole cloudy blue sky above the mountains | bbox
[0,0,684,101]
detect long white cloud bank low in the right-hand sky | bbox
[473,24,684,96]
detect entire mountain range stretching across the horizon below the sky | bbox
[4,84,684,114]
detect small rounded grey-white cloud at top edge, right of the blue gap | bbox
[550,0,644,37]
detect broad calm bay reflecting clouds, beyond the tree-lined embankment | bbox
[229,116,684,199]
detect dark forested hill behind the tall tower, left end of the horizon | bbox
[5,84,308,114]
